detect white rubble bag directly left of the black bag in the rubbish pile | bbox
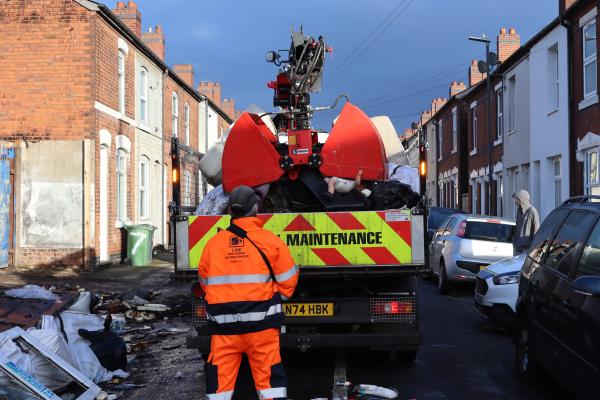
[54,311,129,383]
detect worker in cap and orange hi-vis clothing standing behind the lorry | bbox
[198,186,298,400]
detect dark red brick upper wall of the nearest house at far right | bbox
[569,1,600,195]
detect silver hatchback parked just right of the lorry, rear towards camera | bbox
[429,214,515,294]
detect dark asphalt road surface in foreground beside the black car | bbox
[235,281,571,400]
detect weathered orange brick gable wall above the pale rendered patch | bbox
[0,0,95,140]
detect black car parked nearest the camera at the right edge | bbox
[515,196,600,399]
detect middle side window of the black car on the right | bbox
[544,210,596,275]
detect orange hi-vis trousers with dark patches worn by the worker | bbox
[204,328,287,400]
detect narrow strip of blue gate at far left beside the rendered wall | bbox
[0,144,15,269]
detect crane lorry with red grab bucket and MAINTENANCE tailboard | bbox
[187,30,426,360]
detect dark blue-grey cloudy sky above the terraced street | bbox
[113,0,558,132]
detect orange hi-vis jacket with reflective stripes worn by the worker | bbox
[198,217,298,335]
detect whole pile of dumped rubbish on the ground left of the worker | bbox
[0,285,191,400]
